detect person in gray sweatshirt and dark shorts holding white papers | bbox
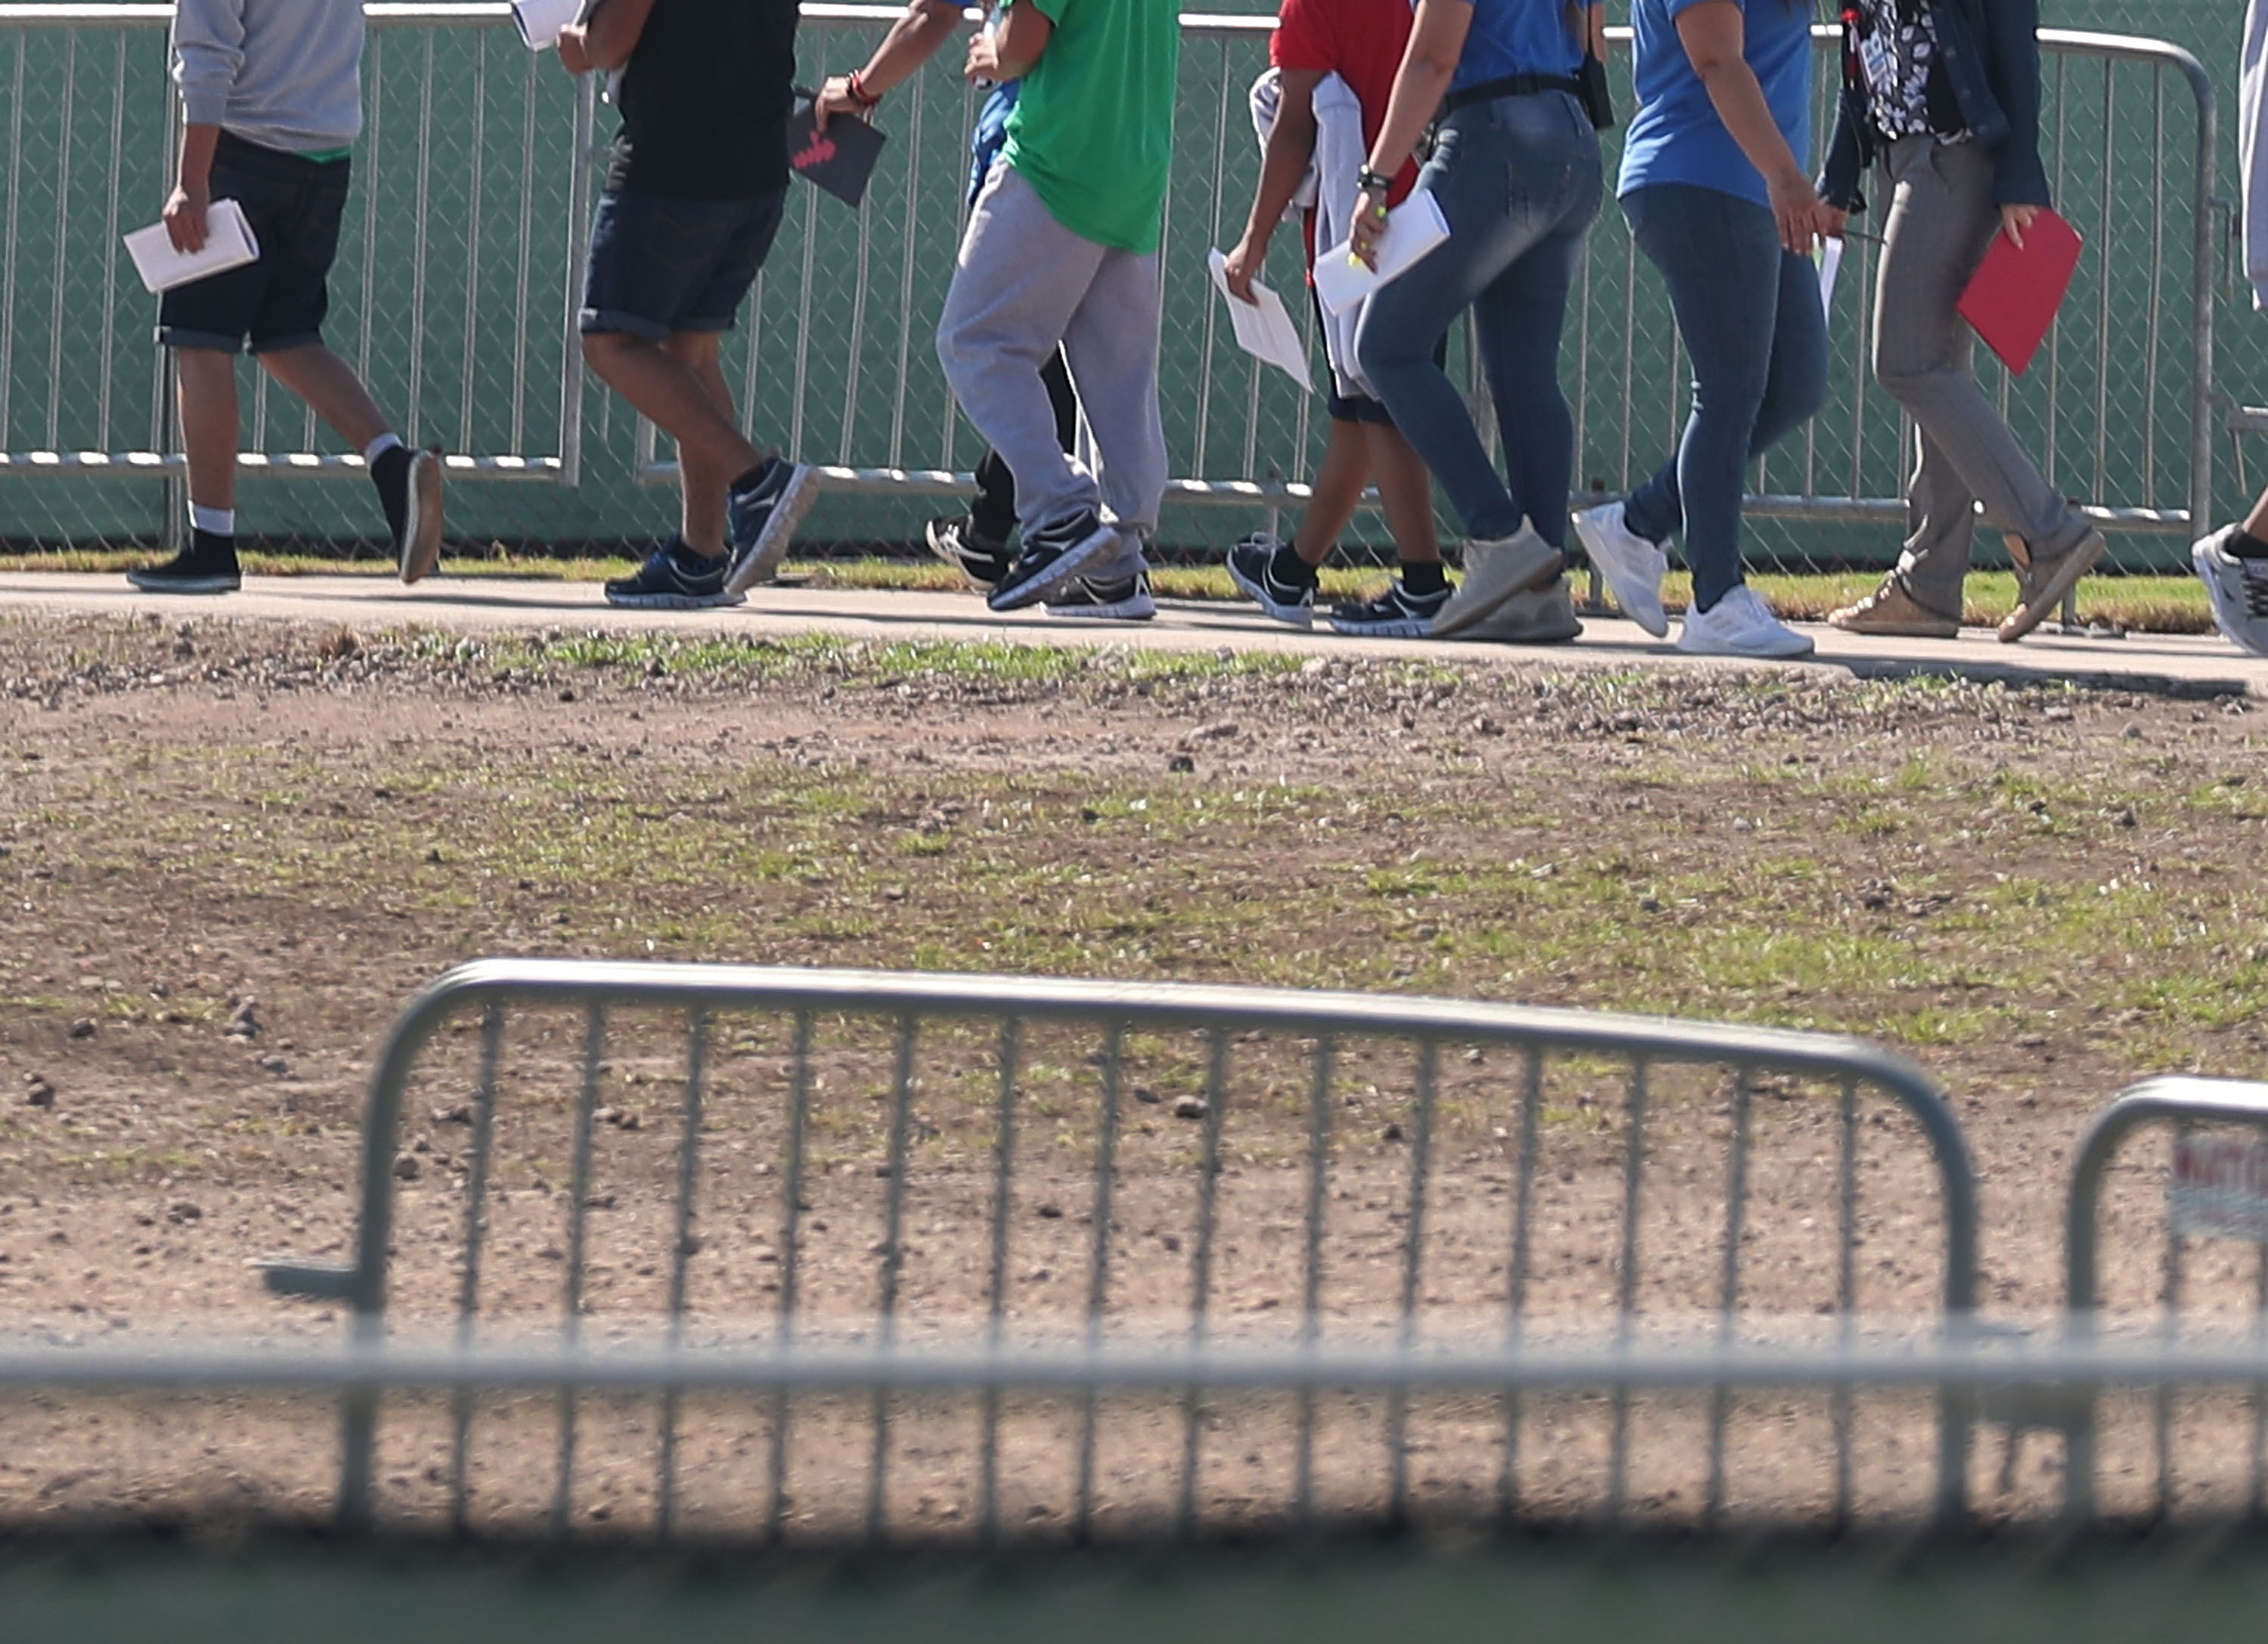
[127,0,442,594]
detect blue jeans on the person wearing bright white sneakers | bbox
[1622,184,1828,610]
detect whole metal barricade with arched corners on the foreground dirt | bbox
[257,961,1978,1535]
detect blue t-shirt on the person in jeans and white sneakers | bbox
[1615,0,1812,206]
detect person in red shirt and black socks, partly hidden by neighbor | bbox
[1225,0,1449,637]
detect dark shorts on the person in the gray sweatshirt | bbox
[156,132,354,354]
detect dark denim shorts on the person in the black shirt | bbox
[576,190,787,342]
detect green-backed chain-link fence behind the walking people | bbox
[0,5,2227,567]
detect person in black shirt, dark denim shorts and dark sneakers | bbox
[560,0,819,610]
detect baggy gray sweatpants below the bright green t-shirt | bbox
[937,161,1166,537]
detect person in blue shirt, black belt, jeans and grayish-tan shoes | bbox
[1352,0,1606,635]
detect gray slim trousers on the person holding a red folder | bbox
[1873,136,2089,617]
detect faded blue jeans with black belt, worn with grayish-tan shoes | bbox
[1354,91,1601,546]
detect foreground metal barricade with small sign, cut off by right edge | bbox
[2064,1077,2268,1524]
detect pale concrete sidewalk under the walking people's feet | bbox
[0,574,2268,696]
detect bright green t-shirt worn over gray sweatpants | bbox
[1007,0,1182,252]
